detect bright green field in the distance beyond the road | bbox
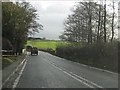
[27,40,67,50]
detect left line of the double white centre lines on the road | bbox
[44,60,95,88]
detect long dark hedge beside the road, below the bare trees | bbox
[56,42,118,72]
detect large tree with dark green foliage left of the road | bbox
[2,2,43,54]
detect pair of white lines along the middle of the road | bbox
[44,60,103,88]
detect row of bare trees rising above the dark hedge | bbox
[60,0,117,44]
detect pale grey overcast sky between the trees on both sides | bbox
[27,0,118,39]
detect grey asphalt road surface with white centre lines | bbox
[13,51,118,88]
